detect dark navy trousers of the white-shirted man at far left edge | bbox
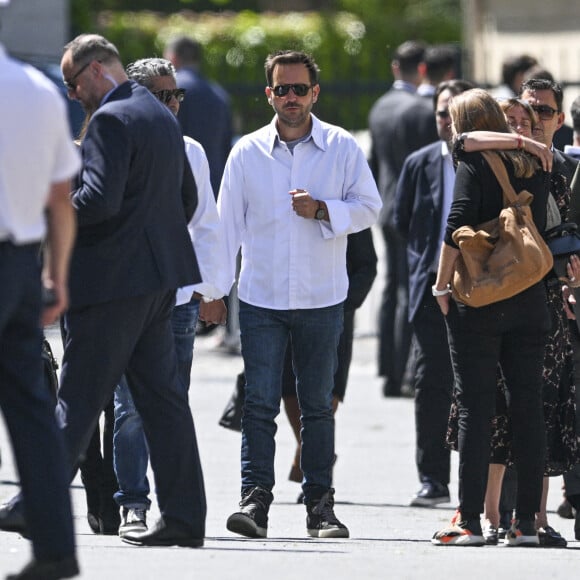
[0,242,75,560]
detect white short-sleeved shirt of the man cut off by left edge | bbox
[0,45,80,244]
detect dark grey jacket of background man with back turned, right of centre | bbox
[369,89,438,226]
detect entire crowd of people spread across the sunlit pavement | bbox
[0,15,580,579]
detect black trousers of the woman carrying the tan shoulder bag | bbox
[446,282,550,518]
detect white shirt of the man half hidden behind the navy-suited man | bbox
[176,137,232,306]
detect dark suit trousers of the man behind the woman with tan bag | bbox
[413,284,453,485]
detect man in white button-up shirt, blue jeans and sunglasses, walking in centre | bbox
[218,51,381,537]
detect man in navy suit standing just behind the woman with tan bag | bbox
[394,80,472,506]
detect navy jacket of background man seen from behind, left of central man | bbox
[176,68,232,197]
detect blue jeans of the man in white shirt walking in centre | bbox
[240,301,343,502]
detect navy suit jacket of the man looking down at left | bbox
[70,82,201,308]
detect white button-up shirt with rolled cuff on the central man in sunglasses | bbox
[218,115,382,310]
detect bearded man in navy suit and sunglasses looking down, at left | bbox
[0,34,206,547]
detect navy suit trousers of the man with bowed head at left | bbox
[58,291,206,537]
